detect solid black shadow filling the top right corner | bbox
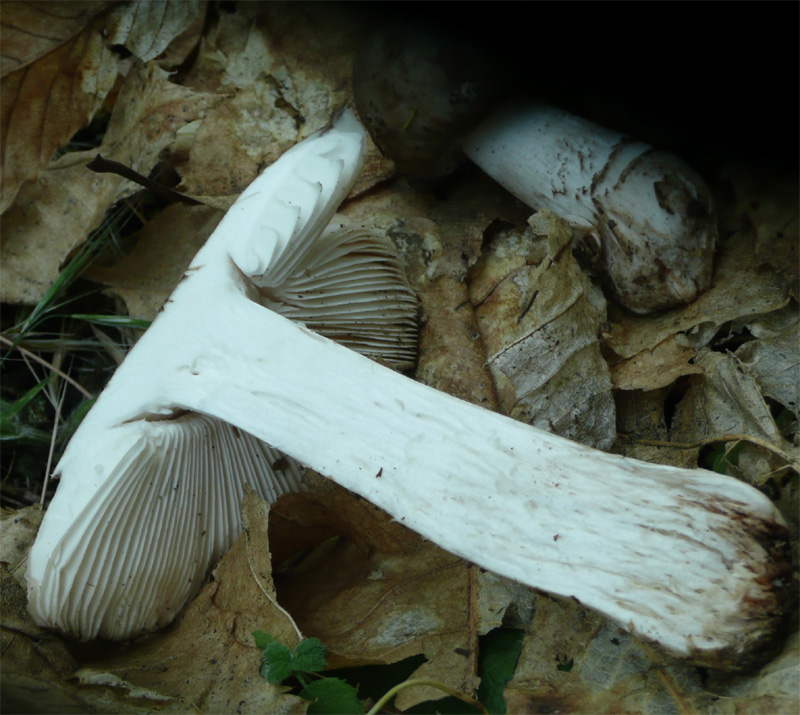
[358,2,800,171]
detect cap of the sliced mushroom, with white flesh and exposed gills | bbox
[23,115,417,639]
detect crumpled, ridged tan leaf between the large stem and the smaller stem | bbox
[470,211,616,448]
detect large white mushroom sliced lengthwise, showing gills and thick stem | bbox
[28,116,788,667]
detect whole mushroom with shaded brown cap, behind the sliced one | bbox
[353,25,717,313]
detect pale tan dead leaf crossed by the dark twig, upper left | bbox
[0,63,215,304]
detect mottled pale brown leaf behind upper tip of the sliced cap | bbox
[177,4,394,205]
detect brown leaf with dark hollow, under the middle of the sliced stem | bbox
[275,476,479,709]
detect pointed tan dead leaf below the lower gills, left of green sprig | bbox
[79,493,307,713]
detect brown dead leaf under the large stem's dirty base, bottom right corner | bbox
[505,595,800,714]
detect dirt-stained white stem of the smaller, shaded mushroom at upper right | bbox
[462,104,717,313]
